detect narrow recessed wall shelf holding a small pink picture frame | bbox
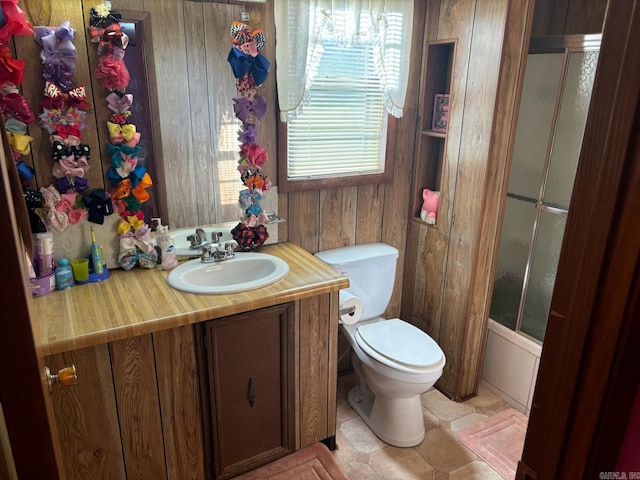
[412,40,456,223]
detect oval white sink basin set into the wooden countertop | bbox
[167,252,289,294]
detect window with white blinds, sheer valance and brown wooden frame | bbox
[275,0,413,192]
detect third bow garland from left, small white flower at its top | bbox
[89,2,158,270]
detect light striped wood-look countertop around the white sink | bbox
[30,243,349,355]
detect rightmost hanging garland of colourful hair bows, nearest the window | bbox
[227,22,271,250]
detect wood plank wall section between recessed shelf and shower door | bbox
[401,0,606,400]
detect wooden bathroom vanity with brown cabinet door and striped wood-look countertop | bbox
[31,243,348,480]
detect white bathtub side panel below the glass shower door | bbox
[481,319,542,415]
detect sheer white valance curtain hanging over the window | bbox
[274,0,413,122]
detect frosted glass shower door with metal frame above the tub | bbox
[491,37,599,342]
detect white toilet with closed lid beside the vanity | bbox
[315,243,445,447]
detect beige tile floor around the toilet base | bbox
[334,374,511,480]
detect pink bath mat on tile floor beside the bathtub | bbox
[458,408,528,480]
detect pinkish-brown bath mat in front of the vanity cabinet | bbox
[234,443,349,480]
